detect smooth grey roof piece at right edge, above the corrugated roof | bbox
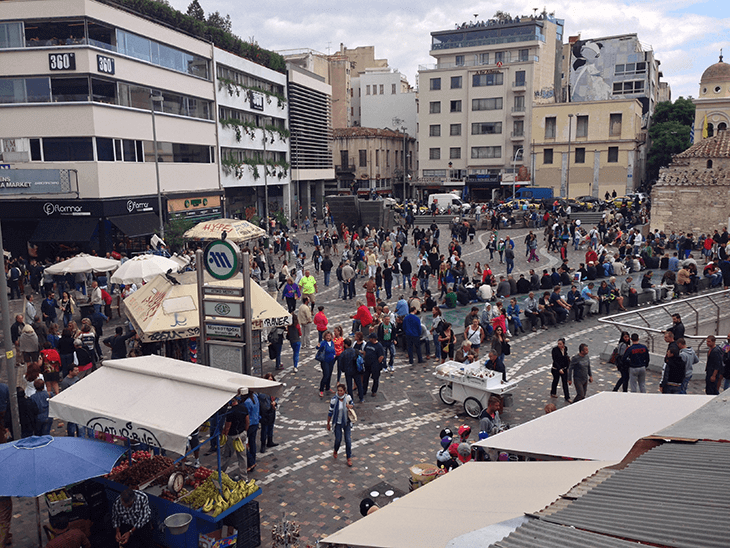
[650,392,730,441]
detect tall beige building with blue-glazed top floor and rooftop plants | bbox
[418,13,563,199]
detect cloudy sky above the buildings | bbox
[171,0,730,99]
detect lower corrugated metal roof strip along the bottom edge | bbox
[490,520,636,548]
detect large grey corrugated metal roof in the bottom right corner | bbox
[541,442,730,548]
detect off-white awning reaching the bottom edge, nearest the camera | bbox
[320,461,615,548]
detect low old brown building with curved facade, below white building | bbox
[333,127,414,196]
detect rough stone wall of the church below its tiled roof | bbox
[651,158,730,237]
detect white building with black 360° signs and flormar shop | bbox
[0,0,221,253]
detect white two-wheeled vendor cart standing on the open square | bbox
[434,361,517,419]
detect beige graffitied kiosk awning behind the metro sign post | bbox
[124,272,291,342]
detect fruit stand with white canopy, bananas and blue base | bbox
[50,356,281,548]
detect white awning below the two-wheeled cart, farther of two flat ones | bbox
[475,392,712,461]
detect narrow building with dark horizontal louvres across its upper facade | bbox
[287,63,337,215]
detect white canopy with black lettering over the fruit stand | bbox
[49,356,281,455]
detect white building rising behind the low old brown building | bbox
[350,68,418,136]
